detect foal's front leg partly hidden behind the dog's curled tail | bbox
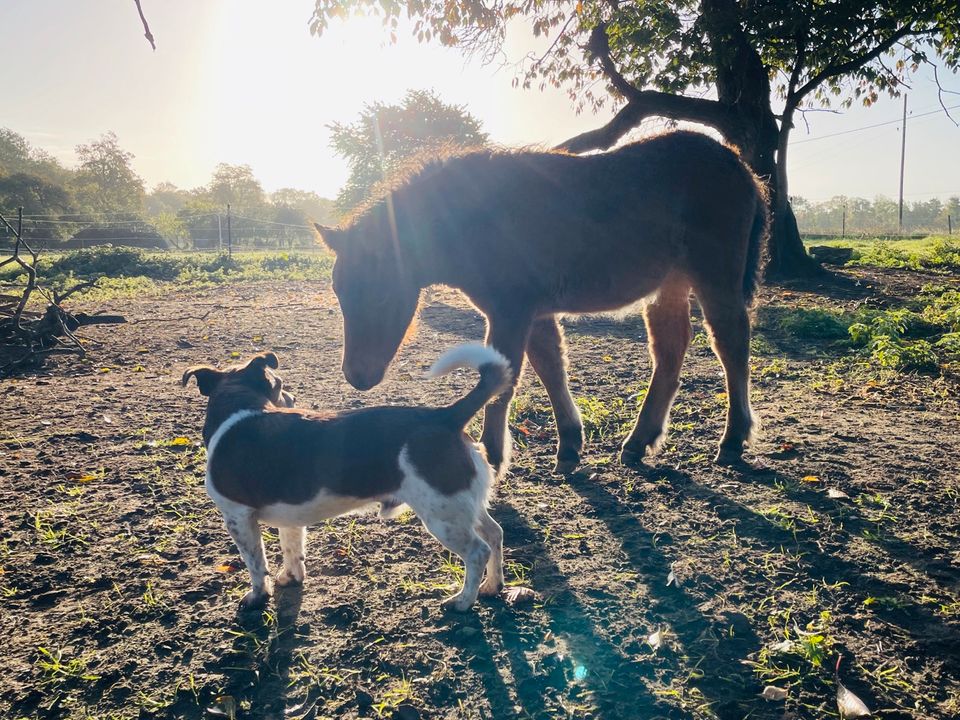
[480,311,533,476]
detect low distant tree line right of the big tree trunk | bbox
[791,195,960,235]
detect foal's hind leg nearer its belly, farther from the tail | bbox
[620,278,692,465]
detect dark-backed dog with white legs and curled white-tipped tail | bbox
[183,344,511,611]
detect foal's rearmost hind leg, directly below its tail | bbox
[694,288,756,465]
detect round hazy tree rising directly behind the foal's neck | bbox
[330,90,487,213]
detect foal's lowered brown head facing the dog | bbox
[316,225,420,390]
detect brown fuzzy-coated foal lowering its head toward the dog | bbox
[317,132,768,471]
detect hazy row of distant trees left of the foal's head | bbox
[0,128,334,248]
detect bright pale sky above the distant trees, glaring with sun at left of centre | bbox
[0,0,960,200]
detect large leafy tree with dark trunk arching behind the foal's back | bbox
[311,0,960,275]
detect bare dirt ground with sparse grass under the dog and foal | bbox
[0,273,960,720]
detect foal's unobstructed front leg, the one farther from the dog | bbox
[527,316,583,473]
